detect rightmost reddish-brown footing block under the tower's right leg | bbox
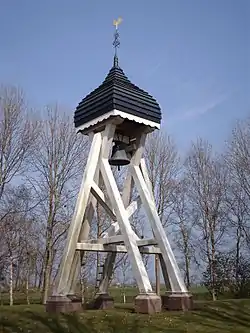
[161,292,193,311]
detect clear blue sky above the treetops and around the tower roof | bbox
[0,0,250,152]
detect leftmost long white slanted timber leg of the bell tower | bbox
[55,133,102,295]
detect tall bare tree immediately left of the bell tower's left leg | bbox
[28,106,86,303]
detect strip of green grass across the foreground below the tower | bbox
[0,300,250,333]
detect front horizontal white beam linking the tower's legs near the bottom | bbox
[76,243,161,254]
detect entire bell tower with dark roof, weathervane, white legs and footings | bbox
[46,19,192,314]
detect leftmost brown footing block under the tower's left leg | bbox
[45,296,83,313]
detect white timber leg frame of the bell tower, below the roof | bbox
[48,117,188,312]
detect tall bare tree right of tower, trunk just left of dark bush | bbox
[186,139,227,300]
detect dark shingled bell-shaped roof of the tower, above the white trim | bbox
[74,56,161,127]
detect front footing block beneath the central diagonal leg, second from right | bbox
[135,294,162,314]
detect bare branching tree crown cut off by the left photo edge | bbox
[0,86,38,199]
